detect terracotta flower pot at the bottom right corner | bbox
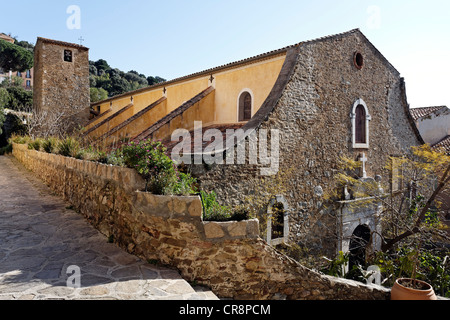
[391,278,437,300]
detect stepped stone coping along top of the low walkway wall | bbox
[13,143,259,241]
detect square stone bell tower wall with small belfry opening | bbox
[33,38,90,134]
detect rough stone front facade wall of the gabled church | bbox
[198,30,421,257]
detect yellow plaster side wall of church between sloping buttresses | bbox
[87,54,286,141]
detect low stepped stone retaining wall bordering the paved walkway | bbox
[13,144,390,300]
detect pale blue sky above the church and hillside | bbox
[0,0,450,107]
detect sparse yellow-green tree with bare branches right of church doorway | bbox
[337,145,450,252]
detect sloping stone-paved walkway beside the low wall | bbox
[0,156,217,300]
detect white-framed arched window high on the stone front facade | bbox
[350,99,372,149]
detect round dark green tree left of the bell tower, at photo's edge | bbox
[0,40,33,72]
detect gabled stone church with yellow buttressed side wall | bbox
[36,29,423,257]
